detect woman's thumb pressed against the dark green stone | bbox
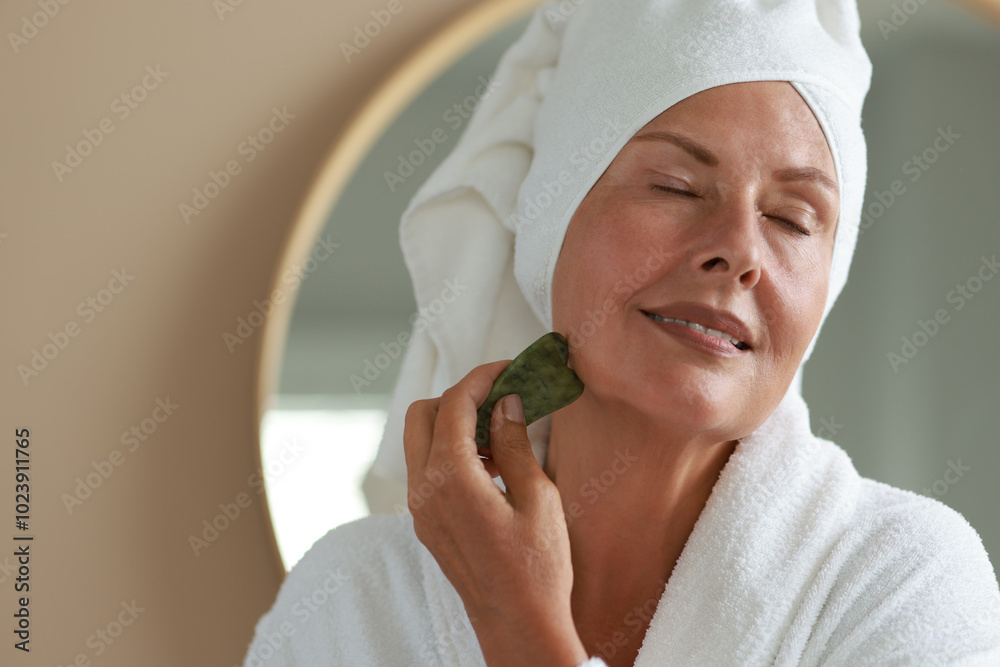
[490,394,549,502]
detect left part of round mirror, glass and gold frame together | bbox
[254,0,540,570]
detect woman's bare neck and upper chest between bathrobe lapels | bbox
[545,392,736,652]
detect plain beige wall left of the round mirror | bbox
[0,0,475,667]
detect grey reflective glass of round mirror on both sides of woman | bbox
[262,0,1000,568]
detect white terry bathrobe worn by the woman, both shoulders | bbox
[244,392,1000,667]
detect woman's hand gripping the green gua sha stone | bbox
[403,360,587,666]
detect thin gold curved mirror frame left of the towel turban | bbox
[254,0,544,576]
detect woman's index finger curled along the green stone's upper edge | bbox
[430,359,511,469]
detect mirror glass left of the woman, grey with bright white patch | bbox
[261,7,529,570]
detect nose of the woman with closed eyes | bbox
[691,194,764,289]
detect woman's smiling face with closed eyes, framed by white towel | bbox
[553,82,839,442]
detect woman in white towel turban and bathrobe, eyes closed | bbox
[245,0,1000,665]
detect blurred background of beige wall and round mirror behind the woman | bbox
[0,0,1000,666]
